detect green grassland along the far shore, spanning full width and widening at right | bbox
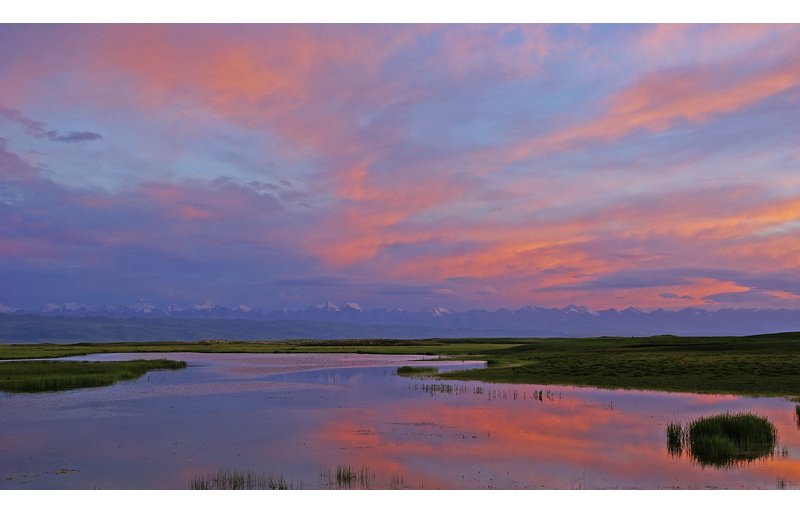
[0,333,800,398]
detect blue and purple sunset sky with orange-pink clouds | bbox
[0,23,800,311]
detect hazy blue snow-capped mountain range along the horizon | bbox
[0,299,800,336]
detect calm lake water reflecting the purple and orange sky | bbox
[0,353,800,489]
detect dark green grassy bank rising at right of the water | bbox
[440,333,800,397]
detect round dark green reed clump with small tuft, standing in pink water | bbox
[667,412,777,468]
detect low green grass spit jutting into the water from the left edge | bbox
[0,360,186,392]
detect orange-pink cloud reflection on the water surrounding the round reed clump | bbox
[304,378,800,489]
